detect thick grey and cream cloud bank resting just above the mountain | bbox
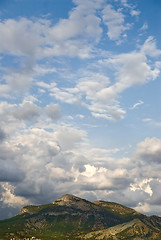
[1,119,161,217]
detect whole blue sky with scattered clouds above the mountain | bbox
[0,0,161,219]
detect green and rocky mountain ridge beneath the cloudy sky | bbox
[0,194,161,240]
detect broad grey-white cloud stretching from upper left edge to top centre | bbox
[0,1,102,63]
